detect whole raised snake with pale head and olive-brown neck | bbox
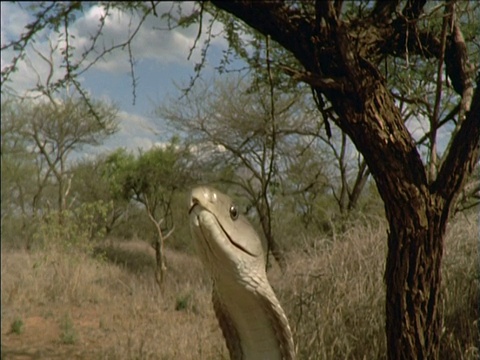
[189,186,295,360]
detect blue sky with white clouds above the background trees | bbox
[1,1,236,156]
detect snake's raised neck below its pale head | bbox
[213,274,294,360]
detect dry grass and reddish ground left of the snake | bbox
[2,243,226,359]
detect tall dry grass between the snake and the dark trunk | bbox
[274,218,386,359]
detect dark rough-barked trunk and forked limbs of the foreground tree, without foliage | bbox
[212,0,480,359]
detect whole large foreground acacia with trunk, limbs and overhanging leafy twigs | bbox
[2,0,480,359]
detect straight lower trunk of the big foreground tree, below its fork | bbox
[385,184,448,359]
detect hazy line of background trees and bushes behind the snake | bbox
[2,73,381,250]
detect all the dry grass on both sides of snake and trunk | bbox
[1,212,479,359]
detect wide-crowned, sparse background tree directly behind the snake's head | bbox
[158,78,326,269]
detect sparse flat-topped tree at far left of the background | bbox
[2,98,116,224]
